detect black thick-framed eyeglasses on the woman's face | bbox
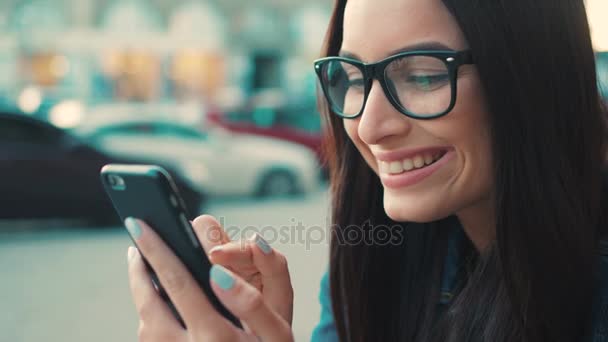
[314,50,473,120]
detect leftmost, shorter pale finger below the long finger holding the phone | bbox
[128,247,183,330]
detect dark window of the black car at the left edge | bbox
[0,118,64,145]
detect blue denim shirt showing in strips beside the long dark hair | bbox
[311,227,608,342]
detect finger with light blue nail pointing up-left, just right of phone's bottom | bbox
[209,265,292,342]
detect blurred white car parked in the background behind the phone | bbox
[76,115,319,196]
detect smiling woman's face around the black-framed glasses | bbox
[341,0,493,222]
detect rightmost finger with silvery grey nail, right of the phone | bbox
[251,233,293,324]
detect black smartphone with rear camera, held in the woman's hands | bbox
[101,164,241,328]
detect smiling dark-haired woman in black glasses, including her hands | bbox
[123,0,608,341]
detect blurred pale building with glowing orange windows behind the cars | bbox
[0,0,329,109]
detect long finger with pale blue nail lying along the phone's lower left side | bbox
[125,218,234,331]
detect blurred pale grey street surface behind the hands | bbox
[0,190,329,342]
